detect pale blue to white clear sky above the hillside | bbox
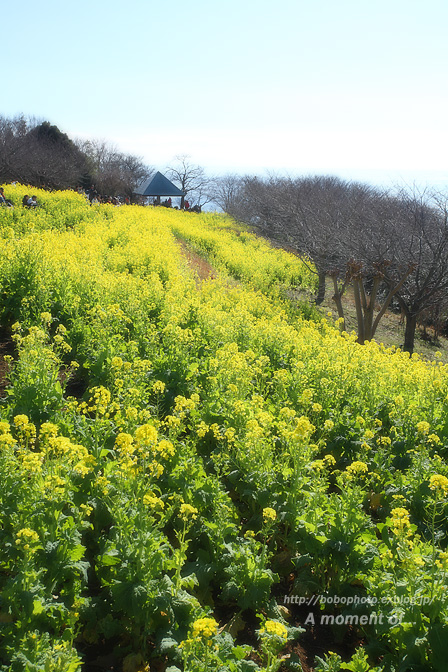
[0,0,448,186]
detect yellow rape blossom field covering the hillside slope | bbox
[0,185,448,672]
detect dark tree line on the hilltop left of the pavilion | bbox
[0,115,153,198]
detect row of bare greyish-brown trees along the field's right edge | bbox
[213,175,448,353]
